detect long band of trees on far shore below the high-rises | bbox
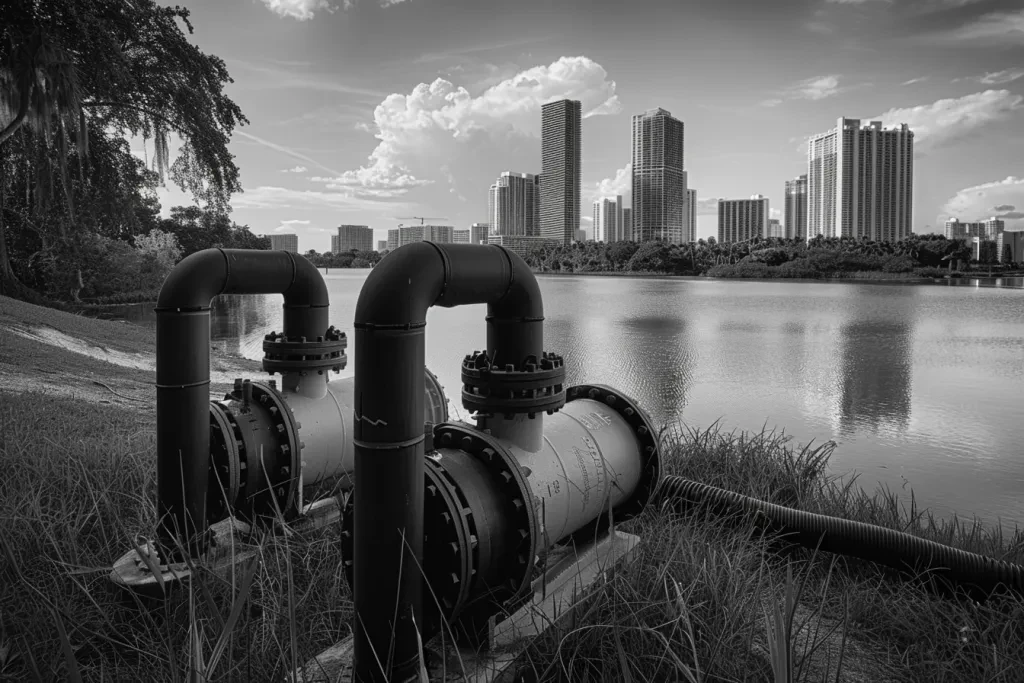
[526,234,996,279]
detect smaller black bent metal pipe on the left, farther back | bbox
[156,249,327,557]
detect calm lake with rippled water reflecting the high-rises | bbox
[97,269,1024,527]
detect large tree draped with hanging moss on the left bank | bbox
[0,0,248,296]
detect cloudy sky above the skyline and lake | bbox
[142,0,1024,252]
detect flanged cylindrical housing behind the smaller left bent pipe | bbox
[207,369,447,523]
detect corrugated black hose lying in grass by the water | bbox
[655,476,1024,595]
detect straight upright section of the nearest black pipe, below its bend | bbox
[353,324,426,681]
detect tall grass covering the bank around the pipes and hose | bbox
[0,296,1024,682]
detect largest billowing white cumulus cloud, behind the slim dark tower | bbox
[339,56,622,195]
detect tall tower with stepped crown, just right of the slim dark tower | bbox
[633,109,689,244]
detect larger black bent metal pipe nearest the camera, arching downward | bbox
[352,242,544,681]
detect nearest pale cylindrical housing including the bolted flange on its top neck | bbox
[342,351,662,645]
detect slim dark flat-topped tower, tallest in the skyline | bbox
[540,99,583,245]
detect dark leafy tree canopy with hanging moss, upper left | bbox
[0,0,248,299]
